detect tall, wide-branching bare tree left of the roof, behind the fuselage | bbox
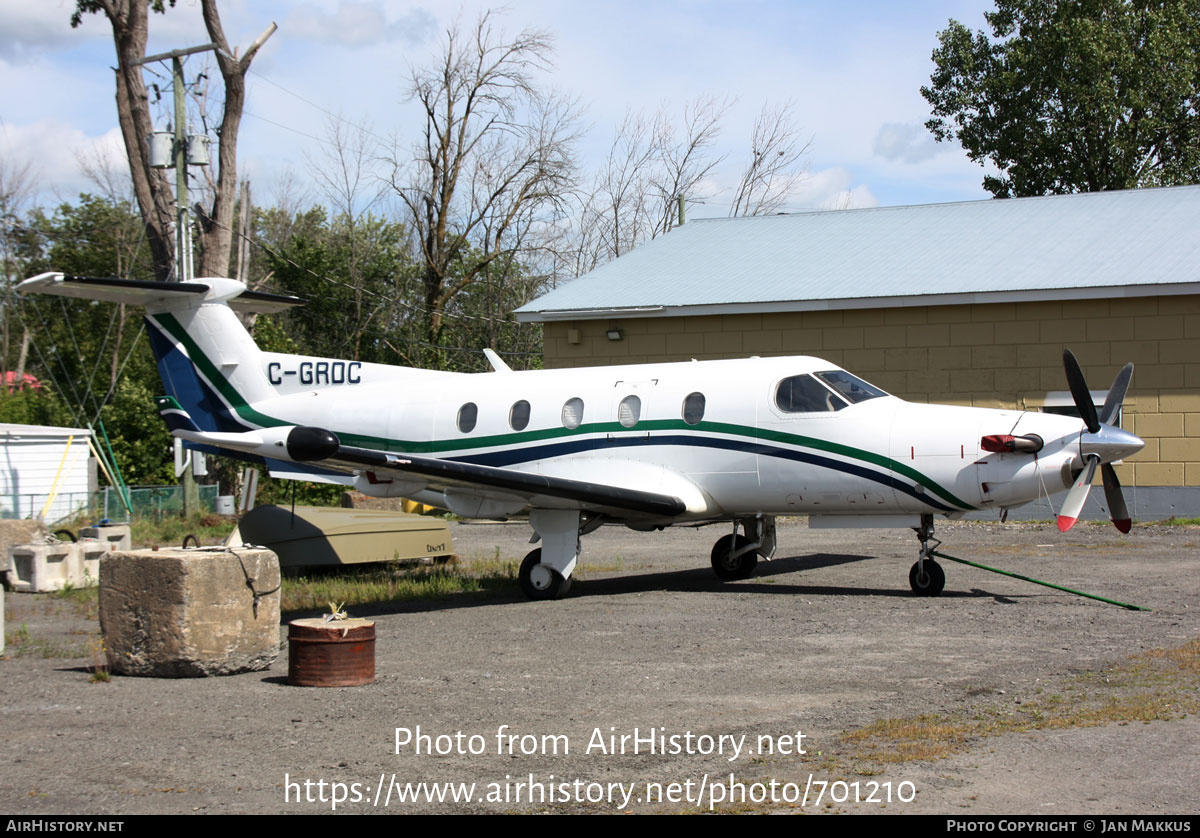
[392,12,577,360]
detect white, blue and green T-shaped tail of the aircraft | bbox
[18,274,302,432]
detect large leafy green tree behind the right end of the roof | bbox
[920,0,1200,198]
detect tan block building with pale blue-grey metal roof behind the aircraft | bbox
[516,186,1200,519]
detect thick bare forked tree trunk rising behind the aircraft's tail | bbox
[71,0,275,280]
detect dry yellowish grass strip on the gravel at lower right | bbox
[841,638,1200,764]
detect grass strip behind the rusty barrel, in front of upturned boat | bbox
[281,559,517,611]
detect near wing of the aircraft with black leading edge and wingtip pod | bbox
[287,427,688,517]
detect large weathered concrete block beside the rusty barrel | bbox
[100,547,280,678]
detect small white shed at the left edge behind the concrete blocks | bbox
[0,424,96,523]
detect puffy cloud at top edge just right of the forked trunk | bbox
[287,0,437,47]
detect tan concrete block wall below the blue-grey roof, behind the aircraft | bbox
[545,295,1200,489]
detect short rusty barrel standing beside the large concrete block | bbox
[288,617,374,687]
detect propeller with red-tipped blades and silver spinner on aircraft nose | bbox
[1058,349,1144,533]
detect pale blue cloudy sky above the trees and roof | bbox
[0,0,992,215]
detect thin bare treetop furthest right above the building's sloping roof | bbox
[730,102,812,216]
